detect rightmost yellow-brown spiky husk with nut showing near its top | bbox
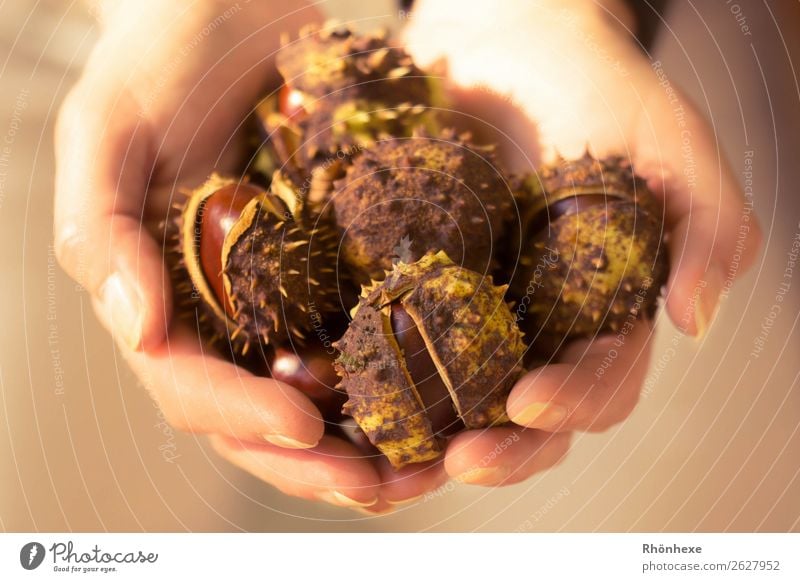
[511,152,669,351]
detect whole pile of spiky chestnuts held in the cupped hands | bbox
[169,25,668,480]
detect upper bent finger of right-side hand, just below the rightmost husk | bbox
[506,320,652,431]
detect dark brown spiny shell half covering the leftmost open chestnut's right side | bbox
[222,176,338,344]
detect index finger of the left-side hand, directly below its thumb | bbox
[118,326,325,448]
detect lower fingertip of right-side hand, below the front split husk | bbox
[444,426,571,486]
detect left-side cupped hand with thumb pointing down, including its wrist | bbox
[55,0,450,505]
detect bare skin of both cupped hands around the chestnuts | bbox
[55,0,760,513]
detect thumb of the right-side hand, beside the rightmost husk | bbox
[636,87,762,336]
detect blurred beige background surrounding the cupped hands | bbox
[0,0,800,531]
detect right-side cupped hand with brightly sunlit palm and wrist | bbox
[405,0,761,485]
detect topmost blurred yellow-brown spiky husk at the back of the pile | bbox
[256,26,444,192]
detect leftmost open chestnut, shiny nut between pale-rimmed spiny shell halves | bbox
[180,175,338,354]
